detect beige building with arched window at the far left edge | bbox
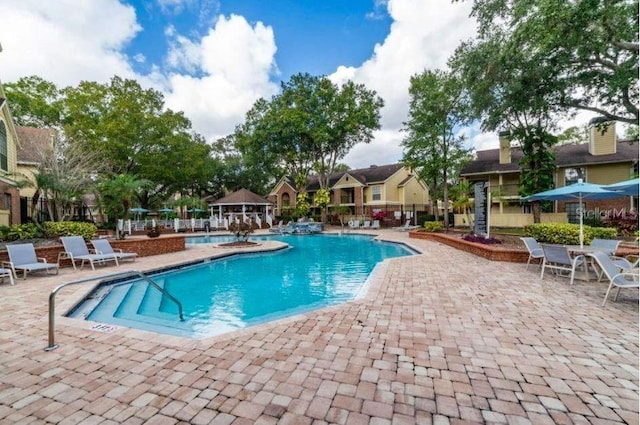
[0,83,21,226]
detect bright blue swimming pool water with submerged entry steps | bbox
[71,235,412,338]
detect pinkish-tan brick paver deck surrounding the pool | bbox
[0,230,639,425]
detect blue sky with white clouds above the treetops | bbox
[0,0,490,168]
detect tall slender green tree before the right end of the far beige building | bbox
[402,70,469,227]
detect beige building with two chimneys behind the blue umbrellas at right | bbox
[456,120,638,227]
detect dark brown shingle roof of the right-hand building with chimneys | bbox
[460,140,638,176]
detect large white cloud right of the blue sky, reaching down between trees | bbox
[330,0,475,168]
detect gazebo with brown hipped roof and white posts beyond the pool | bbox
[209,189,273,227]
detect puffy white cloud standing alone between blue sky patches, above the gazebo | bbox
[166,15,277,141]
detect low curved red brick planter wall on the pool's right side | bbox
[409,232,529,263]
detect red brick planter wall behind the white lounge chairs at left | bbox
[0,235,185,267]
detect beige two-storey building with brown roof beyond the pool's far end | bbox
[269,164,430,225]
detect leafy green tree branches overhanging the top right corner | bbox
[462,0,639,124]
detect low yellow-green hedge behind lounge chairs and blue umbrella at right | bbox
[524,223,617,245]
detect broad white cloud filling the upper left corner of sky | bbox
[0,0,141,86]
